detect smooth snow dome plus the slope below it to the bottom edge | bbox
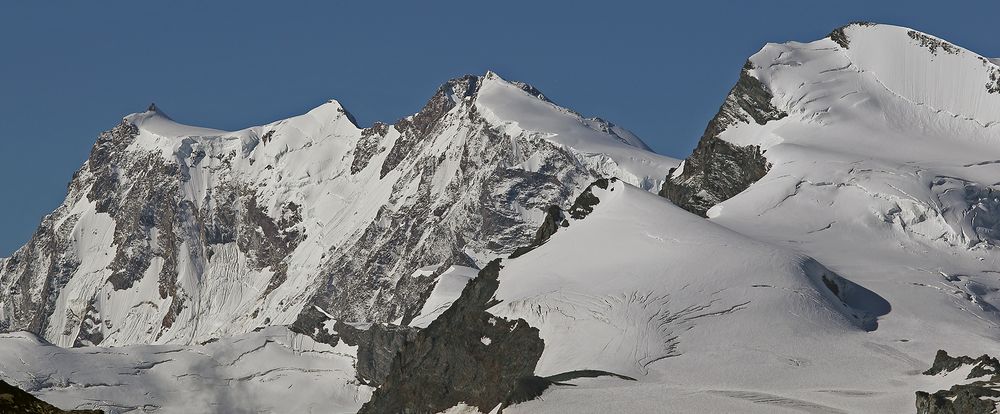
[489,182,976,413]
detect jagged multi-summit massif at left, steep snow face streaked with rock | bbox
[0,73,676,346]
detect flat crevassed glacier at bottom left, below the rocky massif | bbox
[0,327,371,414]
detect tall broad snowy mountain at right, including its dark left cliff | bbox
[661,28,1000,412]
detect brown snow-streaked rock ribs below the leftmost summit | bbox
[0,115,305,346]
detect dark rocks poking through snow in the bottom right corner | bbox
[916,350,1000,414]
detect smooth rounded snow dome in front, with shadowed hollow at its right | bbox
[490,181,888,377]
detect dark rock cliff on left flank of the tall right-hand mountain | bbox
[660,61,788,215]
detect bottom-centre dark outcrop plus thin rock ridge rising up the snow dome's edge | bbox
[358,178,633,413]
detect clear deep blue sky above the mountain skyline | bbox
[0,0,1000,256]
